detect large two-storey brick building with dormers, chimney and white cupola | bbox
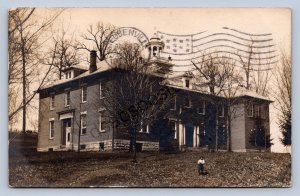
[37,34,271,151]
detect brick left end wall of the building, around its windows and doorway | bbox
[38,78,113,151]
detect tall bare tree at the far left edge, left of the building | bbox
[8,8,62,137]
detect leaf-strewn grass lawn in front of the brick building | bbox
[9,151,291,187]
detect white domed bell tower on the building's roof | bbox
[146,33,165,60]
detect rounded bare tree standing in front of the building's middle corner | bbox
[103,42,172,161]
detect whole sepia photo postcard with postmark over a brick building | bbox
[8,8,292,187]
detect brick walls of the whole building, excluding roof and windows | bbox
[38,69,269,151]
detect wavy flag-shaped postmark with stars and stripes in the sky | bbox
[157,27,278,72]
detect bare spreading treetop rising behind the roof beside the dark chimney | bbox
[78,22,116,61]
